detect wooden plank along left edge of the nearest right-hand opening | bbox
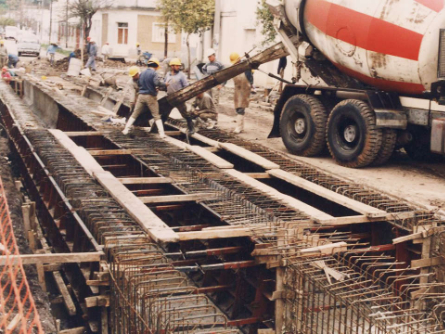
[224,169,335,221]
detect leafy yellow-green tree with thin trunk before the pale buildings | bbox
[158,0,215,78]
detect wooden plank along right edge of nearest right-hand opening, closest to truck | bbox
[267,169,387,218]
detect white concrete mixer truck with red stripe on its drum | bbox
[267,0,445,168]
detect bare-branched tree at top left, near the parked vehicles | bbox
[68,0,112,42]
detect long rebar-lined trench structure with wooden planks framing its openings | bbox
[0,81,445,334]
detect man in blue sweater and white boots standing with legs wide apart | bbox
[122,58,167,138]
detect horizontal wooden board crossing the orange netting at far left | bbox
[0,252,104,266]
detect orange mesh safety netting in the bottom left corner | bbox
[0,178,44,334]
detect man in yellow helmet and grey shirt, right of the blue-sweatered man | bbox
[165,58,195,135]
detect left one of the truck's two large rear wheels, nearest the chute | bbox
[280,95,327,157]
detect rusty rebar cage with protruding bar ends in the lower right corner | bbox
[284,248,445,334]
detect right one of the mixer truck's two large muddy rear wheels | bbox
[326,100,382,168]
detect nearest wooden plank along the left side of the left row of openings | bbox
[93,172,179,242]
